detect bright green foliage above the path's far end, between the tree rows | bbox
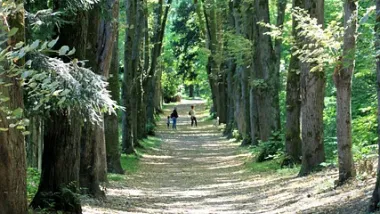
[162,0,211,101]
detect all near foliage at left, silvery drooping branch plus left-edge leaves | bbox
[0,4,118,128]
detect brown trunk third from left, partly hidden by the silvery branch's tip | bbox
[80,0,119,197]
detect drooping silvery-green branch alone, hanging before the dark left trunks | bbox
[27,52,119,121]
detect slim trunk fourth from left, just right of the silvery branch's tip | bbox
[104,28,124,174]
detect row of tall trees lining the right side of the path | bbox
[194,0,380,210]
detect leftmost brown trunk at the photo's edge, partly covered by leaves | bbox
[0,0,27,214]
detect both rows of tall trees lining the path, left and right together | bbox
[0,0,380,213]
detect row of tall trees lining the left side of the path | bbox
[0,0,171,213]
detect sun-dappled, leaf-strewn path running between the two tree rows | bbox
[83,101,374,214]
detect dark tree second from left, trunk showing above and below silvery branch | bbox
[31,0,88,213]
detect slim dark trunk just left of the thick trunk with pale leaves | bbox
[285,0,304,164]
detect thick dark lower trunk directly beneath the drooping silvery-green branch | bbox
[30,109,82,213]
